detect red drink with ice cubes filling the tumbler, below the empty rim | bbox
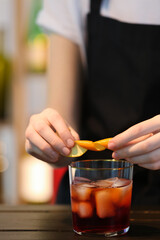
[70,159,132,236]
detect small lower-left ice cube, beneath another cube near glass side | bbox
[78,202,93,218]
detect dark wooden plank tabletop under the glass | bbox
[0,205,160,240]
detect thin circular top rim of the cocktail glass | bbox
[69,159,133,171]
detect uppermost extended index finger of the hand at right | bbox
[108,115,160,150]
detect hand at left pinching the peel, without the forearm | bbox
[25,108,79,165]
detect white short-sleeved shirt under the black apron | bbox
[37,0,160,62]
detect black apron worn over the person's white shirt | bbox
[56,0,160,205]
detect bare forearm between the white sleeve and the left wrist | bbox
[48,35,82,130]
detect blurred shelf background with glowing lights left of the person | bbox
[0,0,56,204]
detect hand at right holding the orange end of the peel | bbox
[108,115,160,170]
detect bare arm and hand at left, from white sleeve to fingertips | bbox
[25,35,81,167]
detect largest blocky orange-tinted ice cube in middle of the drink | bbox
[95,188,115,218]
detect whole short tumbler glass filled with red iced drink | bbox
[69,159,133,237]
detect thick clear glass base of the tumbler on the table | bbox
[73,227,129,237]
